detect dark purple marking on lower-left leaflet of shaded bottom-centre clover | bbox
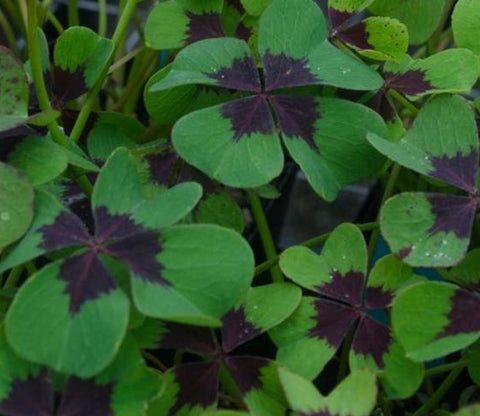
[168,361,220,415]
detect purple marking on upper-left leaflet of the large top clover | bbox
[205,55,262,93]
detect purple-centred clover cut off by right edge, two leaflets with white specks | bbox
[369,96,479,267]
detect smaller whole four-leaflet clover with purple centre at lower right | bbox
[270,224,422,397]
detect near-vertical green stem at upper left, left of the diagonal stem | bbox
[27,0,67,146]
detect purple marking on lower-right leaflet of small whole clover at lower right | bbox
[352,315,391,368]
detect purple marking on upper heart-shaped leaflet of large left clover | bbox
[93,206,145,244]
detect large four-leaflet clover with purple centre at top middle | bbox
[151,0,385,200]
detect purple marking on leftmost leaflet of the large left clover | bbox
[38,210,90,251]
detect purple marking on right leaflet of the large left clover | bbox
[104,231,169,286]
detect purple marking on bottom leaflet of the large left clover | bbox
[58,250,117,315]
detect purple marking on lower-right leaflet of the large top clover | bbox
[269,95,320,150]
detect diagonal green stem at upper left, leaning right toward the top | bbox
[70,0,137,142]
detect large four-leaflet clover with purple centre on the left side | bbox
[0,148,253,377]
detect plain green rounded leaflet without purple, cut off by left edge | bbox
[0,162,34,249]
